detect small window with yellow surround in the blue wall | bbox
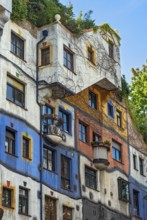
[22,136,31,159]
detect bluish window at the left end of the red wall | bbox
[78,121,88,143]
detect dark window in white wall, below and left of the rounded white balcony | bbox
[85,167,97,189]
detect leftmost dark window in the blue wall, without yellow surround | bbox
[5,127,16,156]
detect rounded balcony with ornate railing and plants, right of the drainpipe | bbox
[43,114,66,145]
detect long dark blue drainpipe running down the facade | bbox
[36,30,48,220]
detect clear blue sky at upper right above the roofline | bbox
[60,0,147,82]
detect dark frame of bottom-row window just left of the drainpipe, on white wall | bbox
[18,186,29,216]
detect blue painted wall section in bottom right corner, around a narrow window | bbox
[129,177,147,220]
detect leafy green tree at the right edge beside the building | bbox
[129,65,147,143]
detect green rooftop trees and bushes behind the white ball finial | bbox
[11,0,95,34]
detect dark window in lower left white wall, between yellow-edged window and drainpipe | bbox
[19,187,29,215]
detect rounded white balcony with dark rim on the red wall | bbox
[91,141,110,170]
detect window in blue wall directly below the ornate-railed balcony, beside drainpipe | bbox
[43,145,55,172]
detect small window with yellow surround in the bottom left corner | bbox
[2,187,12,208]
